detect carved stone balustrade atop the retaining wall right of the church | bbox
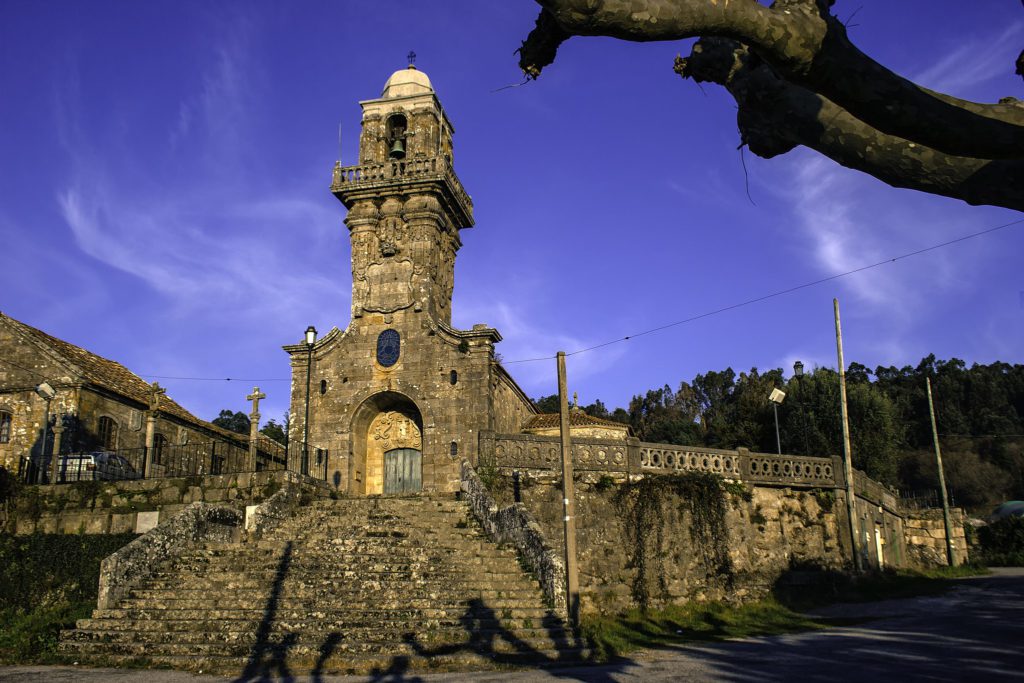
[480,432,839,487]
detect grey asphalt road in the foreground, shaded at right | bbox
[0,568,1024,683]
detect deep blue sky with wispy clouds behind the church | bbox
[0,0,1024,419]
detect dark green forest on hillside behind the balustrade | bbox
[535,355,1024,512]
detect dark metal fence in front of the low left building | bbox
[18,435,329,483]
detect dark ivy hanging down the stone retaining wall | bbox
[615,472,733,609]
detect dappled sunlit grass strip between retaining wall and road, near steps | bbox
[582,600,825,661]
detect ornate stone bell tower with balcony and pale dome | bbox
[331,65,473,326]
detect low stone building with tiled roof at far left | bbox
[0,312,241,475]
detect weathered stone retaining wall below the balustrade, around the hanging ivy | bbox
[486,472,843,612]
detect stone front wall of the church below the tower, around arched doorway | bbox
[292,317,494,494]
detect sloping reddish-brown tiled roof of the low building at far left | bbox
[0,312,237,439]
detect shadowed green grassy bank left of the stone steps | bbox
[0,533,135,664]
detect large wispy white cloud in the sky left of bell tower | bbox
[56,7,347,327]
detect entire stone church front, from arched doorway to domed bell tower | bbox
[285,66,537,496]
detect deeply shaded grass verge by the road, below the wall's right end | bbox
[772,564,988,610]
